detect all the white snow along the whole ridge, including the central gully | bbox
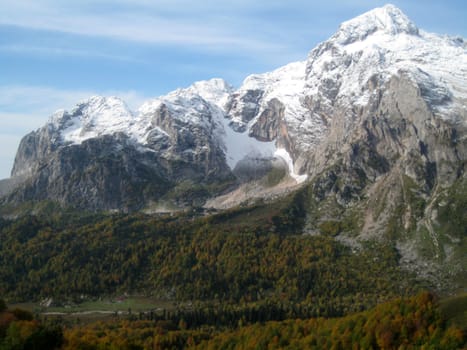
[41,5,467,185]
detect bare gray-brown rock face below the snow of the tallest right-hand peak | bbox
[305,74,467,202]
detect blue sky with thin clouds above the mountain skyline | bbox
[0,0,467,178]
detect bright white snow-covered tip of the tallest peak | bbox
[333,5,419,45]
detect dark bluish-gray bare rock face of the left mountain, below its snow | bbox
[9,136,171,211]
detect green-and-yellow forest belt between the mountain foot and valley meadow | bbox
[0,200,420,317]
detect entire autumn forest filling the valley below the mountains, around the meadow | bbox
[0,192,467,350]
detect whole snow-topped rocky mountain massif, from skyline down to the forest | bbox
[0,5,467,284]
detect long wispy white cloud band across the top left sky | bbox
[0,0,283,51]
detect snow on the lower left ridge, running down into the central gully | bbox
[49,79,282,174]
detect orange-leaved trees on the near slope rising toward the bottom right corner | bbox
[195,293,467,350]
